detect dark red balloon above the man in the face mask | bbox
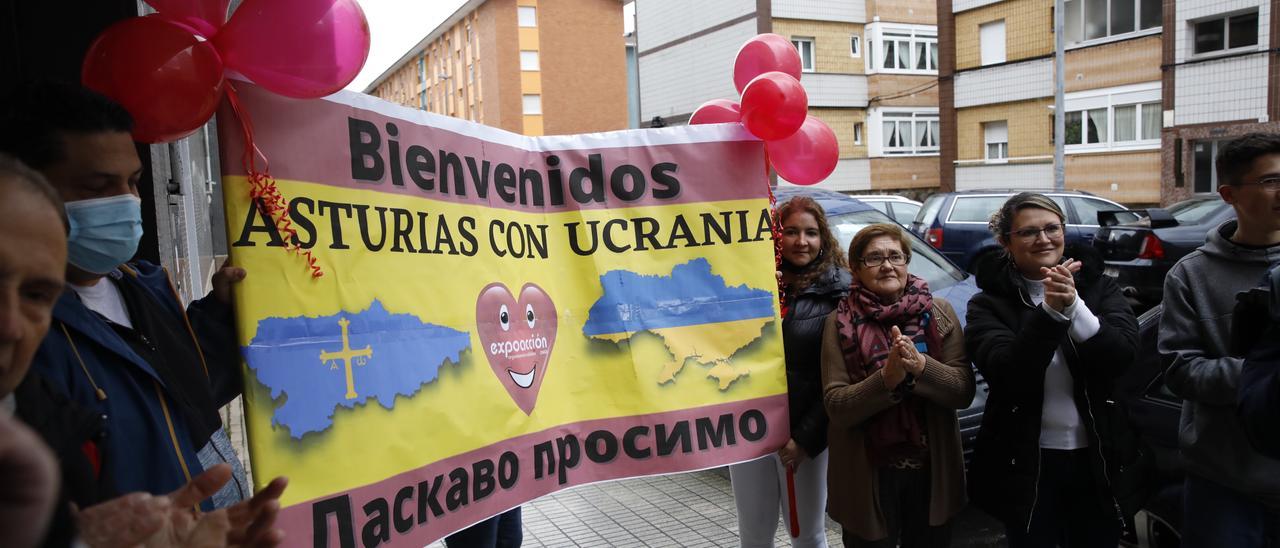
[81,15,223,143]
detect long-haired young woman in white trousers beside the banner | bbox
[730,196,850,548]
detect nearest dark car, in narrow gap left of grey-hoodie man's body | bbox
[1115,305,1185,548]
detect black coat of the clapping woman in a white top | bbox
[965,246,1142,524]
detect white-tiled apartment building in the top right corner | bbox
[1161,0,1280,202]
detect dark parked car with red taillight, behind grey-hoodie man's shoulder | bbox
[1093,195,1235,306]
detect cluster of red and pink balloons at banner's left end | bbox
[81,0,369,143]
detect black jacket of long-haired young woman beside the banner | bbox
[782,268,854,457]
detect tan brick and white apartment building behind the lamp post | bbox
[940,0,1164,204]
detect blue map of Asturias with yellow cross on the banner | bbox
[244,301,471,439]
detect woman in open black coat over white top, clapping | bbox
[965,192,1138,548]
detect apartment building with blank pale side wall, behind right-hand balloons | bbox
[635,0,941,195]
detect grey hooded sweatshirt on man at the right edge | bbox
[1158,220,1280,507]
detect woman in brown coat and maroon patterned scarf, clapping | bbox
[822,224,974,548]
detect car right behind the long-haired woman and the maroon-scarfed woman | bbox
[774,187,987,463]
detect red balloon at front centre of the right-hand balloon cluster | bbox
[742,72,809,141]
